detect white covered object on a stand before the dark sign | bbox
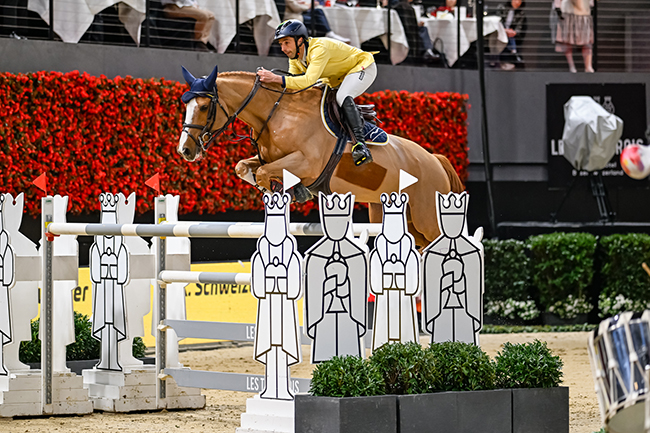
[562,96,623,171]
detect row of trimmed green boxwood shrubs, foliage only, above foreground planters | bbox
[310,340,563,397]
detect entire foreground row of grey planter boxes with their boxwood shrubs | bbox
[295,341,569,433]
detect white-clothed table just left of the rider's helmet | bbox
[198,0,280,56]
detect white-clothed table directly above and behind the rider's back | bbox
[323,6,409,65]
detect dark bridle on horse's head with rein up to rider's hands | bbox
[183,76,260,152]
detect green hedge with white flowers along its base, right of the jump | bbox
[483,233,650,320]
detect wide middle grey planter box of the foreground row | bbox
[397,389,513,433]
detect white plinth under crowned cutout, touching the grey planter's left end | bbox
[235,395,295,433]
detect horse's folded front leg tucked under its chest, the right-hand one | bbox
[256,151,320,202]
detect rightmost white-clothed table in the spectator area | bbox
[422,16,508,66]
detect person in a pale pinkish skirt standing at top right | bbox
[554,0,594,72]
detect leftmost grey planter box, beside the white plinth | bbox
[295,394,397,433]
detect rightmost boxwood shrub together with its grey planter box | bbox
[495,340,569,433]
